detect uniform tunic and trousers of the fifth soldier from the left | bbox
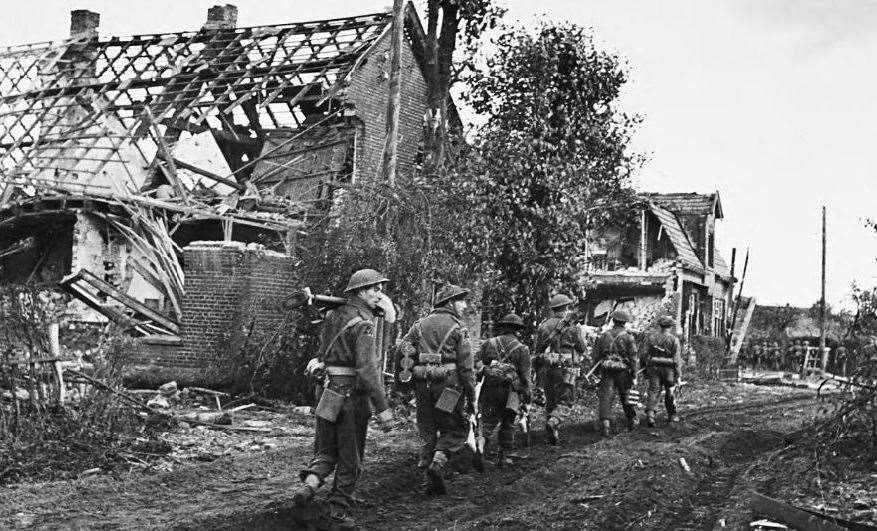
[594,326,639,421]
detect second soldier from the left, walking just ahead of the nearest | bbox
[400,285,475,494]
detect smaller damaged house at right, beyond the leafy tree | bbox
[583,192,745,339]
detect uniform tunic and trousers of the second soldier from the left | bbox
[403,307,475,462]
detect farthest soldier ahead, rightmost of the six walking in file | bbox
[643,316,682,428]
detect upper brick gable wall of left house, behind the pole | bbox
[345,26,427,184]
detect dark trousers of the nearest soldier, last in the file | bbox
[301,378,371,507]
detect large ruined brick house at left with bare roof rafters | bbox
[0,4,448,383]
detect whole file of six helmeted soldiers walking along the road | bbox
[294,269,682,529]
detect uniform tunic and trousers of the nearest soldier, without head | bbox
[301,297,388,507]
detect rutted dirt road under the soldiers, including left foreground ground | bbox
[0,384,836,529]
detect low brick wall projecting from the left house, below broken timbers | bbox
[126,242,296,386]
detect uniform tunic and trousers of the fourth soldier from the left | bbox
[535,317,586,422]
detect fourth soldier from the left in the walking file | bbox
[536,295,585,444]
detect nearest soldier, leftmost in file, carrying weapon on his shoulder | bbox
[294,269,393,529]
